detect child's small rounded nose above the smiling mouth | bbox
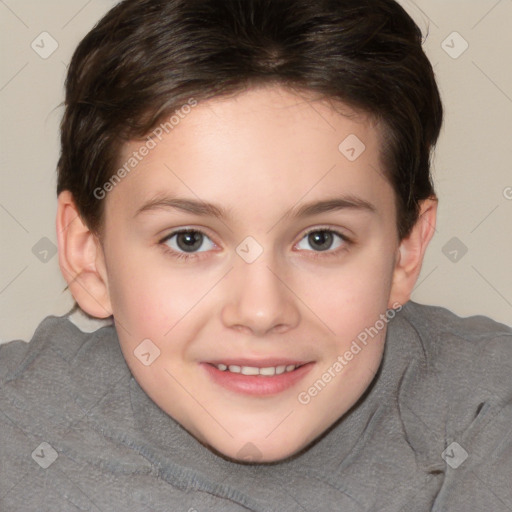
[221,257,300,336]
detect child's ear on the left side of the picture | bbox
[56,190,112,318]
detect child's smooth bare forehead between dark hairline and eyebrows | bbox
[109,86,389,222]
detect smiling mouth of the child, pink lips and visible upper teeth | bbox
[201,359,314,396]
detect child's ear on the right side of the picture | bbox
[388,197,437,307]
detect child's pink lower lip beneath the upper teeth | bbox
[201,363,314,396]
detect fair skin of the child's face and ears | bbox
[57,86,437,462]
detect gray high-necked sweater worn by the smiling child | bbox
[0,302,512,512]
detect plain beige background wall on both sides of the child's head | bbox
[0,0,512,342]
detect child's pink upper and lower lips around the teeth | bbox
[200,359,315,396]
